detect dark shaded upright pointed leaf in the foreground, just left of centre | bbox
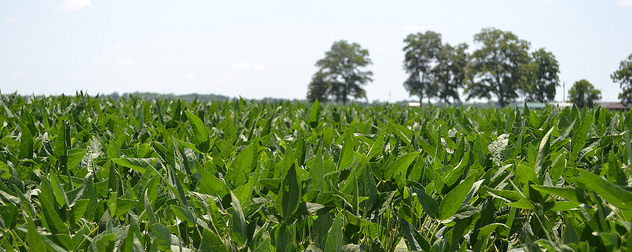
[277,164,301,219]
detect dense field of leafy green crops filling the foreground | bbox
[0,94,632,252]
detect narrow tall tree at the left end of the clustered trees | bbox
[403,31,441,103]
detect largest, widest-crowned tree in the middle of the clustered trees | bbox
[465,28,531,107]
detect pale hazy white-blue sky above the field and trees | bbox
[0,0,632,101]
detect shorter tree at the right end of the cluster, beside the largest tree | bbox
[521,48,560,102]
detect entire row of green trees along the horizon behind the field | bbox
[307,28,632,107]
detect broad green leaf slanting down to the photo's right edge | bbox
[574,169,632,210]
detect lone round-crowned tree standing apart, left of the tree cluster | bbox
[308,40,373,104]
